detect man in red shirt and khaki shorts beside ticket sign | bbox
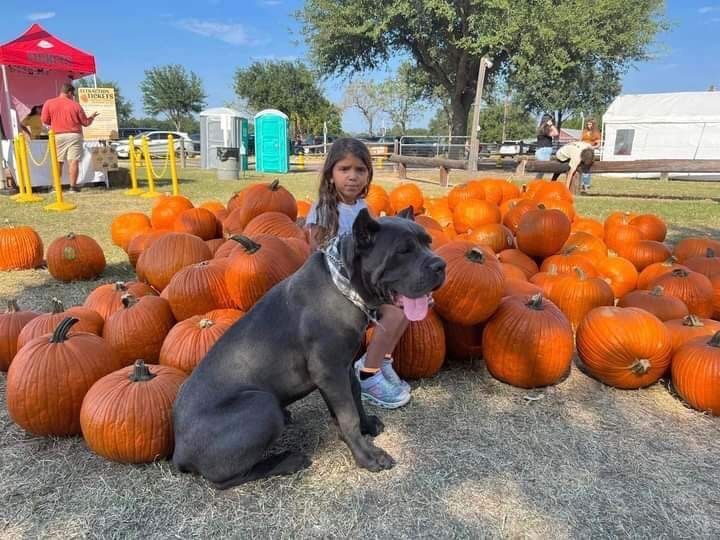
[41,83,99,193]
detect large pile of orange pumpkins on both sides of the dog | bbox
[0,179,720,468]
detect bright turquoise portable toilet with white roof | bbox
[255,109,290,173]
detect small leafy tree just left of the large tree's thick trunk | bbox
[379,62,424,135]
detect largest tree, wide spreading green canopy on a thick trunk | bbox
[298,0,664,135]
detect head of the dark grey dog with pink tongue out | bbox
[350,208,445,320]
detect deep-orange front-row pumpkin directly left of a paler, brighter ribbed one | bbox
[482,294,573,388]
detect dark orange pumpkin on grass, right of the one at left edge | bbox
[46,233,106,281]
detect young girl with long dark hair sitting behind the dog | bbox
[305,138,410,409]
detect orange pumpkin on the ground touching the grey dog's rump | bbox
[80,360,186,463]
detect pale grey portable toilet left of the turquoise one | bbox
[200,107,248,171]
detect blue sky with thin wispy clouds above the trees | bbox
[0,0,720,132]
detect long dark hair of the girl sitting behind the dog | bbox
[315,137,373,245]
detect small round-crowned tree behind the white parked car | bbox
[140,64,206,131]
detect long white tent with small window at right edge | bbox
[602,92,720,177]
